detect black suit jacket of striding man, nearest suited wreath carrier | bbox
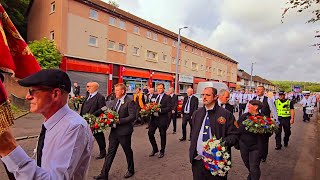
[111,95,136,136]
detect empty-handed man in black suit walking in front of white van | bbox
[179,88,199,141]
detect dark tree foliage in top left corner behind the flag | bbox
[0,0,30,39]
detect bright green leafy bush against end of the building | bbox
[29,38,62,69]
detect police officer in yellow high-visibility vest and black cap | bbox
[275,91,294,150]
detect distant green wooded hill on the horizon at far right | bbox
[270,80,320,92]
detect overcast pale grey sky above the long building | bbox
[105,0,320,82]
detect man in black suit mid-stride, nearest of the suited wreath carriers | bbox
[94,83,136,180]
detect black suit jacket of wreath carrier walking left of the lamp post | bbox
[151,94,171,126]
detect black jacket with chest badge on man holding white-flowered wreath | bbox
[189,105,239,163]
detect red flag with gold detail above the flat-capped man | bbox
[0,4,41,78]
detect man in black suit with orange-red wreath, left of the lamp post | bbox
[148,83,171,158]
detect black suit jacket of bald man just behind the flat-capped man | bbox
[80,92,106,116]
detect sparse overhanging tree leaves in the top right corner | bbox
[281,0,320,50]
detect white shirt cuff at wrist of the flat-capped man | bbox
[1,146,30,172]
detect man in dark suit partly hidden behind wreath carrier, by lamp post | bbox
[168,87,178,134]
